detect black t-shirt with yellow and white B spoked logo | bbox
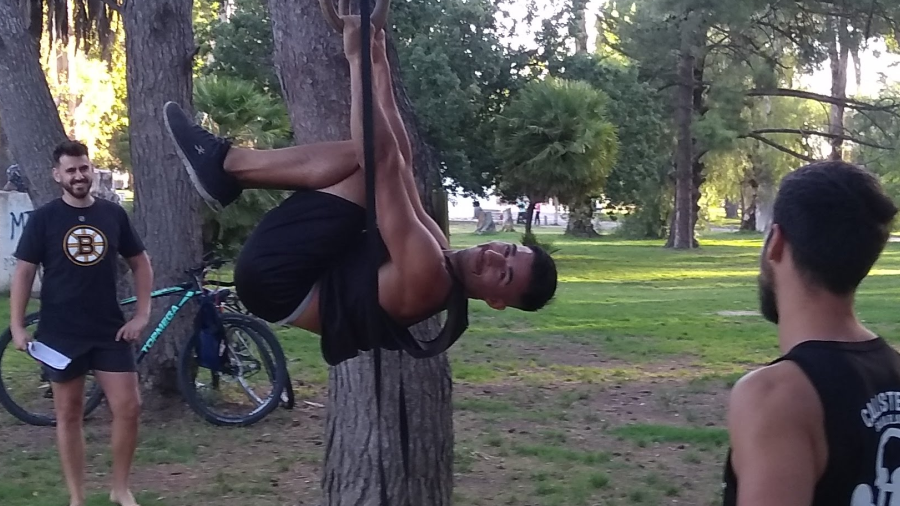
[15,198,144,353]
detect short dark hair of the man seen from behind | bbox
[773,161,897,295]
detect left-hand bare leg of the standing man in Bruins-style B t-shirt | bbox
[53,376,85,506]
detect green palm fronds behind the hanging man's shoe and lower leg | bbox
[194,76,292,258]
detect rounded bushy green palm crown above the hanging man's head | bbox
[497,77,619,210]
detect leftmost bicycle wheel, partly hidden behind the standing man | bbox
[0,313,103,427]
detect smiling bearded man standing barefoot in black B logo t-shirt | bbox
[10,141,153,506]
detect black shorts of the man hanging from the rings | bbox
[234,190,366,323]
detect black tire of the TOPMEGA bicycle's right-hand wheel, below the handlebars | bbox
[178,312,287,427]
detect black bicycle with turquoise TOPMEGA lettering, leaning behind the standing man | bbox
[0,260,290,426]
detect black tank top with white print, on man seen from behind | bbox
[723,338,900,506]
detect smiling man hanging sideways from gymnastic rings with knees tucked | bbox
[165,16,557,365]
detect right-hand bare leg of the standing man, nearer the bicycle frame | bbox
[95,371,141,506]
